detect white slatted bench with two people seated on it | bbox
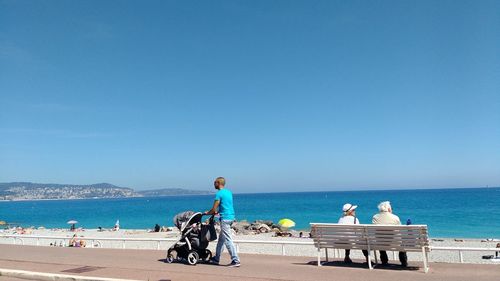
[311,223,430,273]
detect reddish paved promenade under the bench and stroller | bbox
[0,245,500,281]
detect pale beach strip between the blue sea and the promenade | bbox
[0,229,500,265]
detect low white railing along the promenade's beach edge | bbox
[0,234,500,263]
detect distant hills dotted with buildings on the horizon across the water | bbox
[0,182,212,200]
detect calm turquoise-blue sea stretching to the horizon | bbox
[0,188,500,238]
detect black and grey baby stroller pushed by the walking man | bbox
[165,211,217,265]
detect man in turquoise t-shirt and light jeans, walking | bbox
[205,177,240,267]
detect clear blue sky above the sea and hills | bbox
[0,1,500,192]
